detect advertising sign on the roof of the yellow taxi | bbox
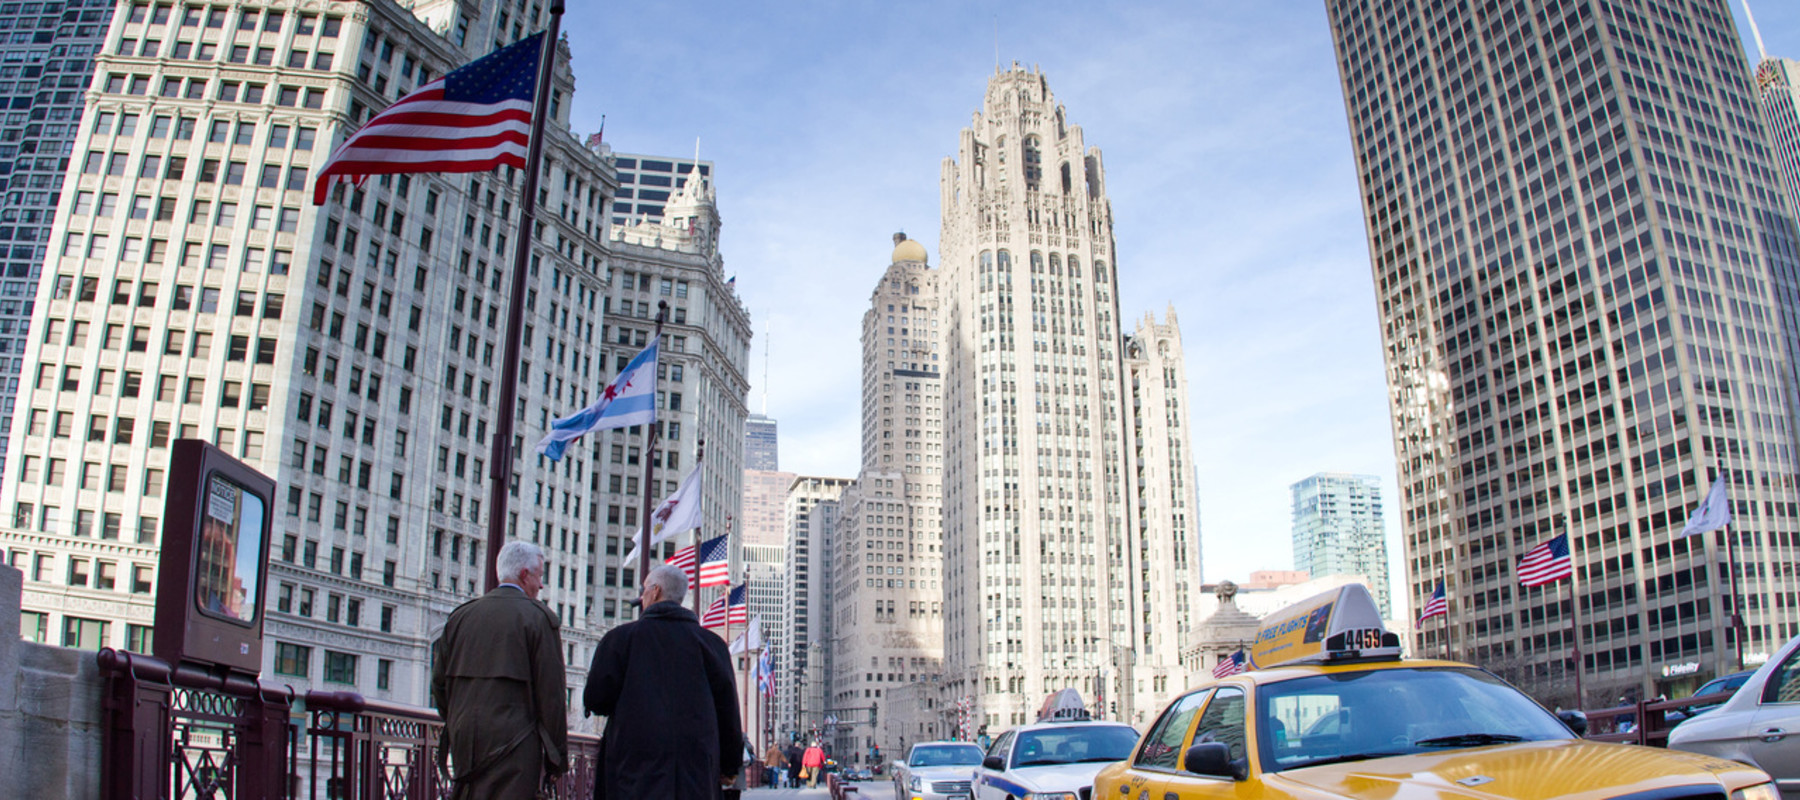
[1249,584,1400,670]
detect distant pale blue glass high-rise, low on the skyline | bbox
[1289,472,1393,618]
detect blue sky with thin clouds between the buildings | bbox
[563,0,1800,614]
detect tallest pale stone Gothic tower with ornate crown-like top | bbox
[943,65,1190,730]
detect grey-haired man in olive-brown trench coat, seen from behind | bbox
[432,541,569,800]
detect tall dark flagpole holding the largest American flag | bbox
[488,0,563,591]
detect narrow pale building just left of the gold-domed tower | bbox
[776,476,851,741]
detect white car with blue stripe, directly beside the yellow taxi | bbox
[972,719,1138,800]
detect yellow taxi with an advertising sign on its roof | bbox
[1093,586,1780,800]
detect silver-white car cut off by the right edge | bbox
[1669,636,1800,800]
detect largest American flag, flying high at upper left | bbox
[313,34,544,205]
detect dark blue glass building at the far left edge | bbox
[0,0,116,483]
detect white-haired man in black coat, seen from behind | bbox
[581,564,743,800]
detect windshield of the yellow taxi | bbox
[1256,667,1571,773]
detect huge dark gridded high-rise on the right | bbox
[1327,0,1800,705]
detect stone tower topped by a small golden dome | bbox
[828,234,943,762]
